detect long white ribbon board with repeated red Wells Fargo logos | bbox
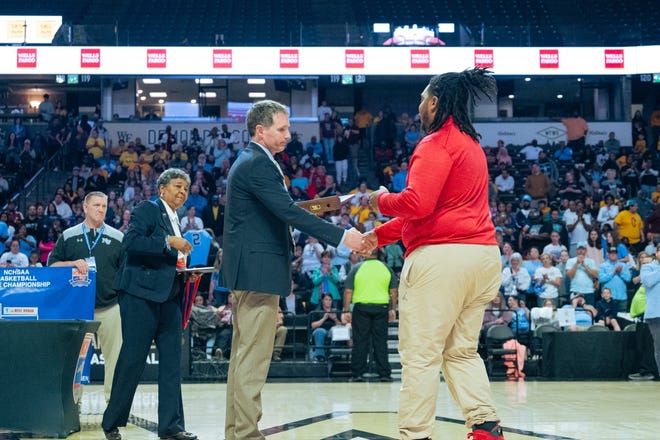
[0,45,660,77]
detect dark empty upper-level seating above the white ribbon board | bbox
[3,0,660,46]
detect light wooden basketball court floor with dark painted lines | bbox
[0,380,660,440]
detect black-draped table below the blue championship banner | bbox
[0,320,100,438]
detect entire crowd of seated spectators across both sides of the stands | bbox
[0,103,660,372]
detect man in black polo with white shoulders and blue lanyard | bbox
[48,191,124,402]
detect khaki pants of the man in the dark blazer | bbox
[225,290,279,440]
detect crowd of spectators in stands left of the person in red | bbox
[0,104,403,322]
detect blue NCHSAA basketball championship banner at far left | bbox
[0,267,96,387]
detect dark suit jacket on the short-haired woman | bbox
[114,199,178,303]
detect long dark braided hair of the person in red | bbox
[427,67,497,142]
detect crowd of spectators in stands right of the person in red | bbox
[474,122,660,354]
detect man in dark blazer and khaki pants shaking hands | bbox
[222,100,362,440]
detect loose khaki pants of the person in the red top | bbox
[399,244,501,439]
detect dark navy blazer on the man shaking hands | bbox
[223,142,344,296]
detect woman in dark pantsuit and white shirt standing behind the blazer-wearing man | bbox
[101,168,197,440]
